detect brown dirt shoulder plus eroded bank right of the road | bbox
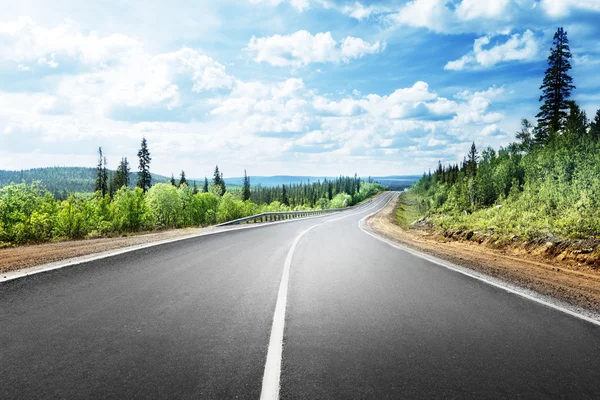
[367,194,600,312]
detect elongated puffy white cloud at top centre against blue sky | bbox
[247,31,385,67]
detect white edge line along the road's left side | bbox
[0,196,379,283]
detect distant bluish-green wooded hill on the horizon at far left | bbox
[0,167,203,197]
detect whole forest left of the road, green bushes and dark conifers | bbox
[0,138,384,247]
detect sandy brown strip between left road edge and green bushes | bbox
[0,227,215,273]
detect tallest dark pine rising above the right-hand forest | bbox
[535,28,575,145]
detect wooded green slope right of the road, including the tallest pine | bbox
[410,28,600,239]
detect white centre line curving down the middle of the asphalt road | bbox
[260,192,393,400]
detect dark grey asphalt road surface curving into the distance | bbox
[0,194,600,399]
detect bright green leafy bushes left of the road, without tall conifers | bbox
[0,173,382,245]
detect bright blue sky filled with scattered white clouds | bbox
[0,0,600,178]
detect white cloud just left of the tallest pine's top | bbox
[444,30,539,71]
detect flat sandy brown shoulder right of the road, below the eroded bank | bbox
[366,194,600,312]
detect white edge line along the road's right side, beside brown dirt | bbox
[358,194,600,326]
